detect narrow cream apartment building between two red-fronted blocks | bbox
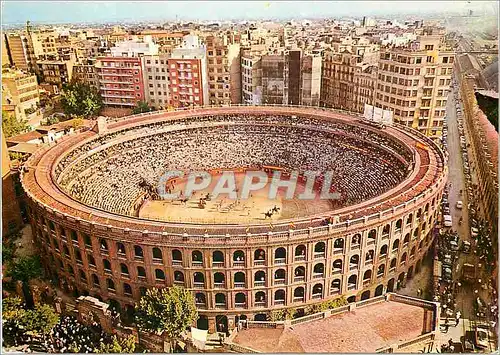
[142,54,170,109]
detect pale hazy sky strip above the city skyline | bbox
[2,0,498,24]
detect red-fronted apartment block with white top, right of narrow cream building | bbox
[168,35,209,107]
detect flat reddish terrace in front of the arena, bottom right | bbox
[234,302,425,353]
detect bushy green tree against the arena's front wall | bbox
[136,286,198,341]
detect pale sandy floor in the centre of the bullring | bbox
[139,173,332,224]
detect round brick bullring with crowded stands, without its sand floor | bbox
[22,106,447,331]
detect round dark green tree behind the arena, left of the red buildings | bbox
[61,82,102,118]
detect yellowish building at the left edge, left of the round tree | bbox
[2,70,42,126]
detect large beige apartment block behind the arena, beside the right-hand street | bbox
[374,34,454,138]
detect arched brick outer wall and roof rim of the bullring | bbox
[22,107,448,331]
